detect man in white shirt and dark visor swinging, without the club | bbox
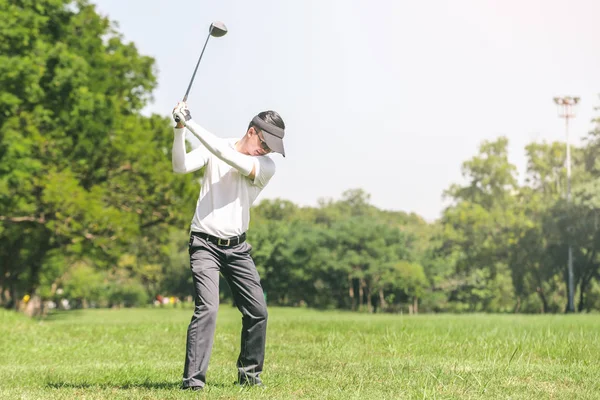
[172,103,285,390]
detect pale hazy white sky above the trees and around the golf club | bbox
[92,0,600,221]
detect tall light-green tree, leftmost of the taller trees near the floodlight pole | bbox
[440,137,519,311]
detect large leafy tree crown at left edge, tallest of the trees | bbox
[0,0,195,305]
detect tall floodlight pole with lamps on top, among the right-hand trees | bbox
[554,96,579,313]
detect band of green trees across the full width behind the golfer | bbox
[0,0,600,313]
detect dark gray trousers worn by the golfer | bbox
[183,235,267,388]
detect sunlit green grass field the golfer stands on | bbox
[0,305,600,400]
